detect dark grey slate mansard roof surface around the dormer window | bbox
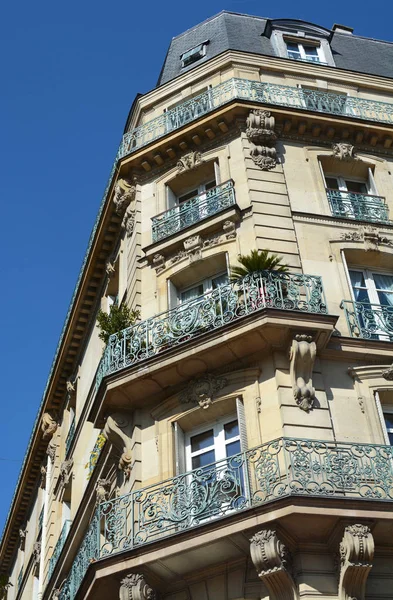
[157,11,393,86]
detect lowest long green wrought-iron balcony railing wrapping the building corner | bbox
[56,438,393,600]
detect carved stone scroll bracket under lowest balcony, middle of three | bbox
[250,529,298,600]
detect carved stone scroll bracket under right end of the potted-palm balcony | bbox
[289,334,317,412]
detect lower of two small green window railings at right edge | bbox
[341,300,393,342]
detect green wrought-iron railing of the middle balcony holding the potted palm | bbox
[96,271,327,389]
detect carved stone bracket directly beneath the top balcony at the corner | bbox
[246,109,277,171]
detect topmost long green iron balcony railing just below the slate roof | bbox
[117,78,393,159]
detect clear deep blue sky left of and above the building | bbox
[0,0,393,531]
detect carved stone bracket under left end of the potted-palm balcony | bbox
[104,412,133,481]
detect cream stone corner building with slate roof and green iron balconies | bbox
[0,12,393,600]
